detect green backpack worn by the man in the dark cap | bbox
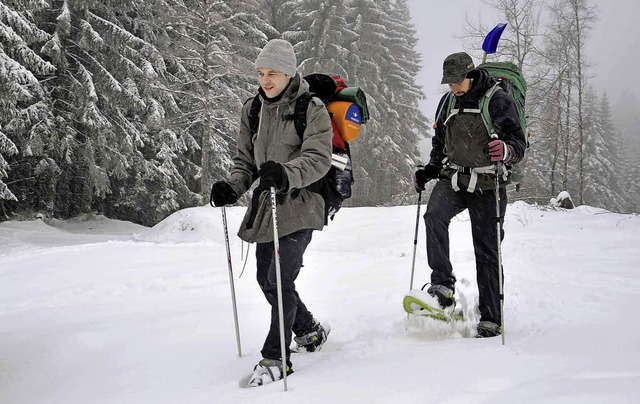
[438,62,531,191]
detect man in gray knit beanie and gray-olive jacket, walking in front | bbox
[211,39,333,386]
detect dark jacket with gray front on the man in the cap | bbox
[430,69,526,190]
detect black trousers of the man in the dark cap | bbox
[424,180,507,325]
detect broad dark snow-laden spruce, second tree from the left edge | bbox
[38,1,193,224]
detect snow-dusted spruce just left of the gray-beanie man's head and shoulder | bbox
[158,0,273,210]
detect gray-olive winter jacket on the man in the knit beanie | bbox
[229,74,333,243]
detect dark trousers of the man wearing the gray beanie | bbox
[256,229,314,364]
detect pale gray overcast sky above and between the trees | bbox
[409,0,640,139]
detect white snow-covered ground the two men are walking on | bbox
[0,203,640,404]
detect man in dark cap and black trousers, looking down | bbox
[414,52,526,337]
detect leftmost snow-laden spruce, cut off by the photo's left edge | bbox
[0,0,55,217]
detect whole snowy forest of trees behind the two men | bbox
[0,0,640,226]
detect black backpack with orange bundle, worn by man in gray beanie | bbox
[249,73,369,224]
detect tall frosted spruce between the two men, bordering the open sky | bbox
[347,0,428,205]
